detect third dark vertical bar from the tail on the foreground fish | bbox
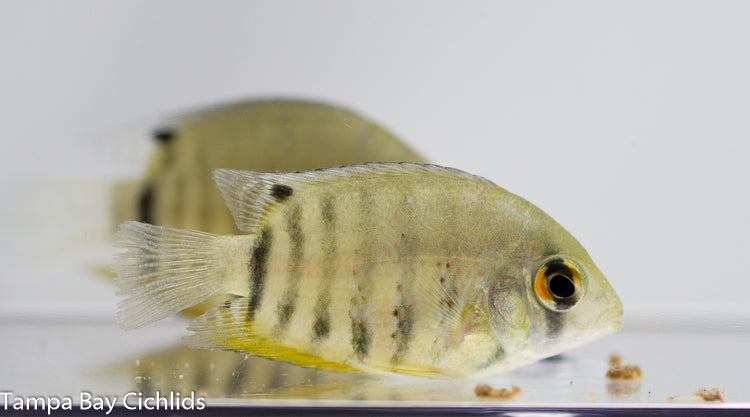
[312,195,337,340]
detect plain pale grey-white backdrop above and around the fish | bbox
[0,1,750,323]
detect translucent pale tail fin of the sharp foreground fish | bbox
[112,221,248,329]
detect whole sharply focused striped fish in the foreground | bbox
[113,162,623,379]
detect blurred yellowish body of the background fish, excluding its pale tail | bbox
[112,98,427,234]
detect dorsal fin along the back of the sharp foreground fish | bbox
[214,162,490,233]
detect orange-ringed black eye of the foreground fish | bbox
[534,258,586,312]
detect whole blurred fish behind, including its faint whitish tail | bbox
[23,97,427,274]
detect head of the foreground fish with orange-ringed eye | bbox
[488,224,623,367]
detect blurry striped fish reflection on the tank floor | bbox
[120,346,482,401]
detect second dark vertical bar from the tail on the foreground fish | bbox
[276,204,305,330]
